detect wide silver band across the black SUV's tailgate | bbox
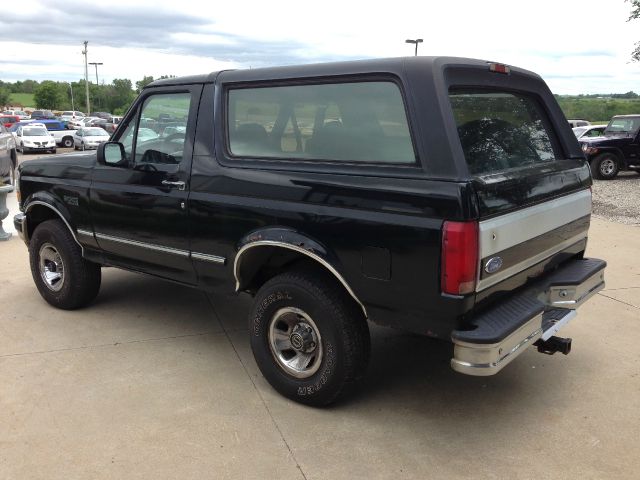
[479,190,591,258]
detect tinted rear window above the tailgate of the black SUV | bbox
[449,89,557,175]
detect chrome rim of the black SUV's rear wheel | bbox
[269,307,323,378]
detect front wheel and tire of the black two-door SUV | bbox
[29,220,101,310]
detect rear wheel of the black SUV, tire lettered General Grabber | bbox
[249,270,371,406]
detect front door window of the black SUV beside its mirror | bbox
[119,93,191,165]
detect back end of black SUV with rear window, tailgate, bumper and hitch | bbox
[440,64,606,375]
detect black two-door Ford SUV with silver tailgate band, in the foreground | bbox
[14,57,605,405]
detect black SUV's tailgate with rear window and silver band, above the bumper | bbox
[449,87,591,303]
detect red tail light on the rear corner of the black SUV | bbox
[440,221,478,295]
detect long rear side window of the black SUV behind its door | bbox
[227,82,416,164]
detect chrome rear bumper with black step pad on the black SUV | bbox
[451,258,607,376]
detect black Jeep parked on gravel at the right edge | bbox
[580,115,640,180]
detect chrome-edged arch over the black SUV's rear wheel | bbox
[233,227,367,317]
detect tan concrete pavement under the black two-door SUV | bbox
[0,149,640,479]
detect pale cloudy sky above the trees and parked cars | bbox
[0,0,640,94]
